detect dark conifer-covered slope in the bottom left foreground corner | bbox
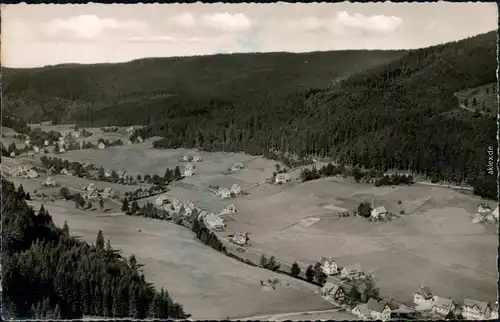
[1,178,188,320]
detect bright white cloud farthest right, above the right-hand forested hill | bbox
[335,11,403,33]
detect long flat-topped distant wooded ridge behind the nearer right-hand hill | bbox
[3,51,405,122]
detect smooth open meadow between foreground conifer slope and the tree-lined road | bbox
[33,203,331,319]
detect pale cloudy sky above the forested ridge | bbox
[1,2,498,68]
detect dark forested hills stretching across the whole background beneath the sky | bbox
[4,32,497,198]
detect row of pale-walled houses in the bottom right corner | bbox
[413,286,498,320]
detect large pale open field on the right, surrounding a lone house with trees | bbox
[227,178,498,301]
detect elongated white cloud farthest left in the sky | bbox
[45,15,147,40]
